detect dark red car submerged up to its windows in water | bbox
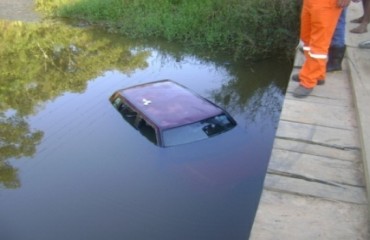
[110,79,236,147]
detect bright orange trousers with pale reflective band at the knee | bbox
[299,0,343,88]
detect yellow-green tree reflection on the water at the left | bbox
[0,21,149,188]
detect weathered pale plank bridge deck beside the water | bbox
[250,3,370,240]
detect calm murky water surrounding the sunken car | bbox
[0,19,291,240]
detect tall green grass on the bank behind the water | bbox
[37,0,299,59]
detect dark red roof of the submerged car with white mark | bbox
[118,79,223,129]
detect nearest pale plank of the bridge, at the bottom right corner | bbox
[250,190,369,240]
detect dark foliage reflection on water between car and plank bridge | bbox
[211,60,291,129]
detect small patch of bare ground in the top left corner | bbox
[0,0,41,22]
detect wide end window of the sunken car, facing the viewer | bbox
[163,114,236,147]
